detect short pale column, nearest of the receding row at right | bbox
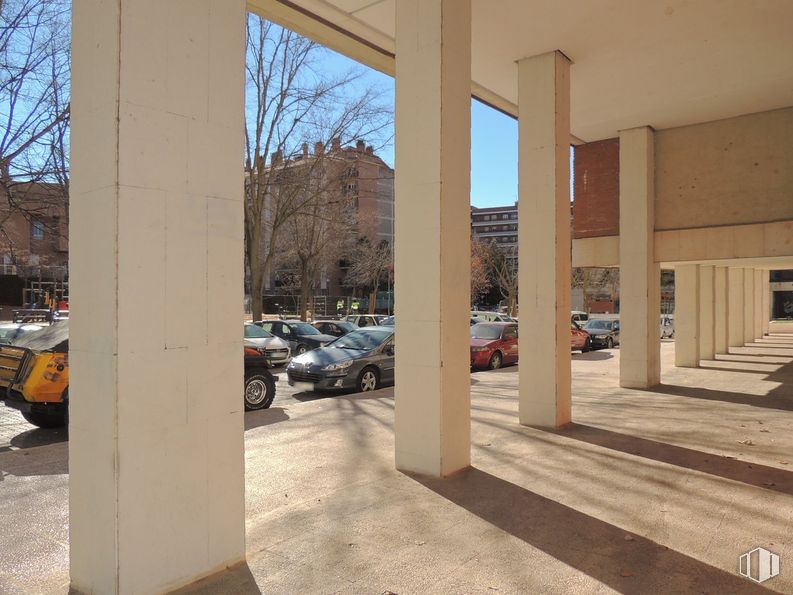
[675,264,700,368]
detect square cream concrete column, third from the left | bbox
[518,52,571,427]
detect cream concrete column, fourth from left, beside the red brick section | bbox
[620,127,660,388]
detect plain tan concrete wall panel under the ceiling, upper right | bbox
[655,108,793,230]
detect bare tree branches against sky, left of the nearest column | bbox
[0,0,71,270]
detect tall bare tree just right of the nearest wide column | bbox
[245,15,392,319]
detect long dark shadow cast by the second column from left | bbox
[414,468,773,593]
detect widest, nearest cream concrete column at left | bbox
[69,0,245,593]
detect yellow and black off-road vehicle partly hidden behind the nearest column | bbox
[4,320,277,428]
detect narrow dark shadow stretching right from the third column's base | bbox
[545,423,793,495]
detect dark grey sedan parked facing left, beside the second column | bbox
[286,326,394,392]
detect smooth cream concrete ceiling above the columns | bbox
[262,0,793,141]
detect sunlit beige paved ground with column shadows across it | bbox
[0,336,793,594]
